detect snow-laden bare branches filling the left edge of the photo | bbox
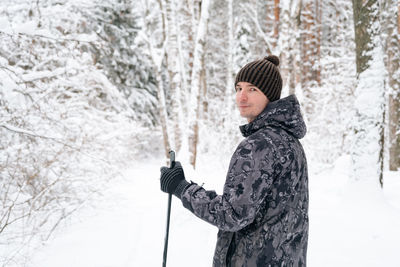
[0,1,148,265]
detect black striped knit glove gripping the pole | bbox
[160,161,190,198]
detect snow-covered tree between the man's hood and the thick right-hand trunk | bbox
[307,0,356,165]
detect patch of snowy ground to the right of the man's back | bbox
[308,157,400,266]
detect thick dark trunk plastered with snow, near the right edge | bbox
[351,0,385,186]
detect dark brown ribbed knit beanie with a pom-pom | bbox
[235,55,282,102]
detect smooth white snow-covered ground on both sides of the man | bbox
[28,157,400,267]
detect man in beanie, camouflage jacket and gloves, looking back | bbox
[160,56,308,267]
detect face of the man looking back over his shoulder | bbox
[236,82,269,122]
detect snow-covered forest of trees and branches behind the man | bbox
[0,0,400,266]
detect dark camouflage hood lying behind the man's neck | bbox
[240,95,307,139]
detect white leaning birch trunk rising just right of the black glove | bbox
[189,0,209,168]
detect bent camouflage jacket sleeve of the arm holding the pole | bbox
[181,137,275,232]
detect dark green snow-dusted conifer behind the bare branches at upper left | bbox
[85,0,158,125]
